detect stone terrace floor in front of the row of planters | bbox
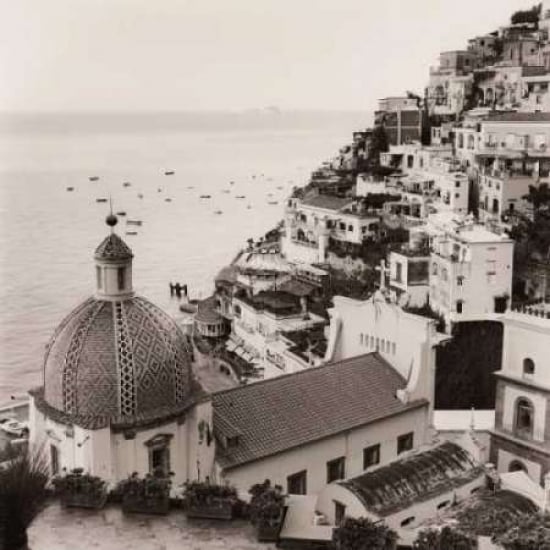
[28,502,275,550]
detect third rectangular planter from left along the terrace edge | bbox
[183,479,238,519]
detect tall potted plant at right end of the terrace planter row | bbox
[249,479,286,542]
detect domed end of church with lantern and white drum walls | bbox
[30,215,214,490]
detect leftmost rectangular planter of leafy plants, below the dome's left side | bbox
[52,468,107,510]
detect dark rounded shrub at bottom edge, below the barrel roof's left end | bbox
[332,518,397,550]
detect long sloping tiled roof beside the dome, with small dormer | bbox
[212,353,428,468]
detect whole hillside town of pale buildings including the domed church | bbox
[31,5,550,544]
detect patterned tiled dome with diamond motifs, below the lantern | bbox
[44,296,196,423]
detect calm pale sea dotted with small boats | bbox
[0,113,368,403]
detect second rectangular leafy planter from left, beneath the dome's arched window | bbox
[115,470,172,514]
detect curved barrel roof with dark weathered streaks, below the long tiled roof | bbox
[338,441,483,517]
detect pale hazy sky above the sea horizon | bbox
[0,0,535,112]
